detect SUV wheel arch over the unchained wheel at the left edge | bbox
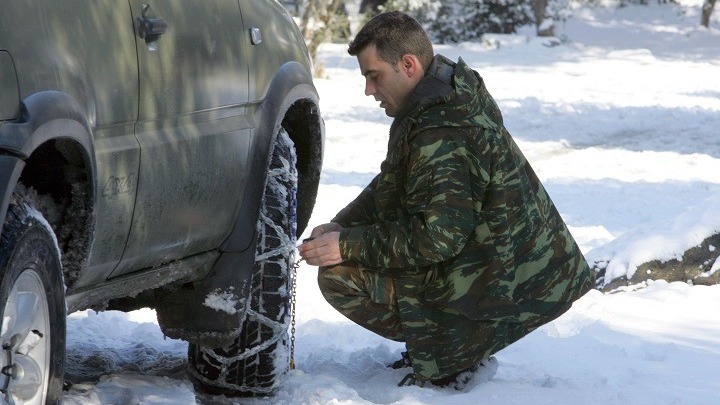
[0,91,95,285]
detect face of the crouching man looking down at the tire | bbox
[357,44,422,117]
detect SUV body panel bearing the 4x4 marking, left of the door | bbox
[13,0,140,285]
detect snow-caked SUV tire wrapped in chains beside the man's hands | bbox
[188,129,297,396]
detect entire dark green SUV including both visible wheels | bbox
[0,0,324,404]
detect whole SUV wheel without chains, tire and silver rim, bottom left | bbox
[0,195,66,405]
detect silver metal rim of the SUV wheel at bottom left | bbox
[0,269,50,405]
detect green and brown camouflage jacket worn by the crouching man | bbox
[333,55,594,378]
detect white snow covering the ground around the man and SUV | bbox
[64,0,720,405]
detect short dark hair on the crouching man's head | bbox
[348,11,435,71]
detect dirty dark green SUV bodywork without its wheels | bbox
[0,0,324,403]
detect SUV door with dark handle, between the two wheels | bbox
[113,0,251,276]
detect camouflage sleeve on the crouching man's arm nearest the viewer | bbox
[340,128,489,269]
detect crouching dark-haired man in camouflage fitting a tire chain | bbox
[299,12,594,386]
